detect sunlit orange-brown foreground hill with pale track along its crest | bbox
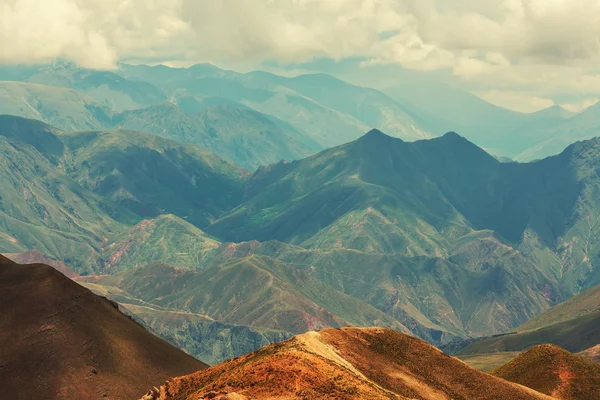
[145,328,550,400]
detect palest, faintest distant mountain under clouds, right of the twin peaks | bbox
[384,80,580,161]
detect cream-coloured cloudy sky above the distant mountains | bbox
[0,0,600,111]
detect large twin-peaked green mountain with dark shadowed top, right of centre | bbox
[208,131,600,335]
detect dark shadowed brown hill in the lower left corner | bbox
[0,256,206,400]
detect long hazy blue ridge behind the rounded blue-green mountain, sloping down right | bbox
[121,64,431,146]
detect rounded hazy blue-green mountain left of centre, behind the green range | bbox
[113,103,321,169]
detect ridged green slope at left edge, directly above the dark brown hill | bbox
[0,116,133,272]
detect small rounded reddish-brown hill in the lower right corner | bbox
[492,344,600,400]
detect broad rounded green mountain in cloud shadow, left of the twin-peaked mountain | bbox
[61,131,245,226]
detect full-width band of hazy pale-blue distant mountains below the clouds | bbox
[0,62,599,164]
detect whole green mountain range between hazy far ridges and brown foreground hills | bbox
[0,116,600,368]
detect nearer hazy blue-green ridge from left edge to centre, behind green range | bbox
[0,78,323,169]
